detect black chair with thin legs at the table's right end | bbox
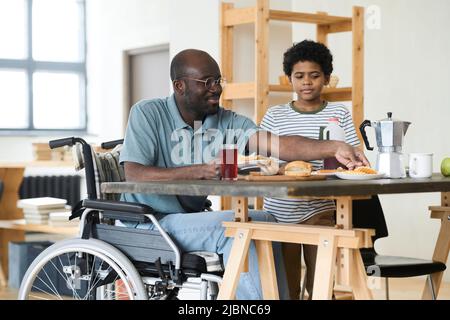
[353,196,446,300]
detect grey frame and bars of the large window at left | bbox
[0,0,88,135]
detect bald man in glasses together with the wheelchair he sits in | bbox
[19,49,368,299]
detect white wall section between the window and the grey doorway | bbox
[87,0,170,140]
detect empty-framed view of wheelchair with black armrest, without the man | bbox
[18,137,223,300]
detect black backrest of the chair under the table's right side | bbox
[353,195,388,242]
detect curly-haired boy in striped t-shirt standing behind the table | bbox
[261,40,360,298]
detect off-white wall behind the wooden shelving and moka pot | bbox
[293,0,450,281]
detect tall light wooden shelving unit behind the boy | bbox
[220,0,364,209]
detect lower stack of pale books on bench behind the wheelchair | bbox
[17,197,71,224]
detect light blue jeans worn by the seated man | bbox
[127,210,289,300]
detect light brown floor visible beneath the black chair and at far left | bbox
[0,278,450,300]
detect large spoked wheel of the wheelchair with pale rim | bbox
[18,239,148,300]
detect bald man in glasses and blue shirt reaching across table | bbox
[120,49,368,299]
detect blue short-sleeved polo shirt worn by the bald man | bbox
[120,95,258,213]
